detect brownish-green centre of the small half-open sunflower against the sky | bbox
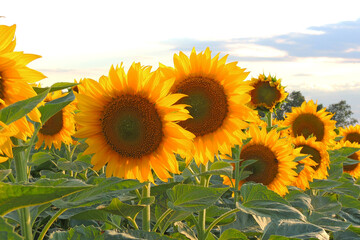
[250,81,281,108]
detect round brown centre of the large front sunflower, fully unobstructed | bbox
[101,95,163,158]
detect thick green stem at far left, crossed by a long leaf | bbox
[13,138,32,240]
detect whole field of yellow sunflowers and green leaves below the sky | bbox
[0,25,360,240]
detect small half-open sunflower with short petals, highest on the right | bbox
[249,74,288,112]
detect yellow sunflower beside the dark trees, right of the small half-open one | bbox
[284,100,336,145]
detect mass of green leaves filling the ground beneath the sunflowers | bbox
[0,84,360,240]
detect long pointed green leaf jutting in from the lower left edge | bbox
[0,179,90,215]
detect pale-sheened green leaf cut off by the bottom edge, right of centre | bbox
[262,219,329,240]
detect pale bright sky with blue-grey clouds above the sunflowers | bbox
[0,0,360,122]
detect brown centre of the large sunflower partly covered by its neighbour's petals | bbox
[172,76,228,136]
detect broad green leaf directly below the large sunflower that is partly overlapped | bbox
[167,184,228,212]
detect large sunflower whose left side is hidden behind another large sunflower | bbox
[160,48,257,165]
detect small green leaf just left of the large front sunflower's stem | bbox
[98,198,145,219]
